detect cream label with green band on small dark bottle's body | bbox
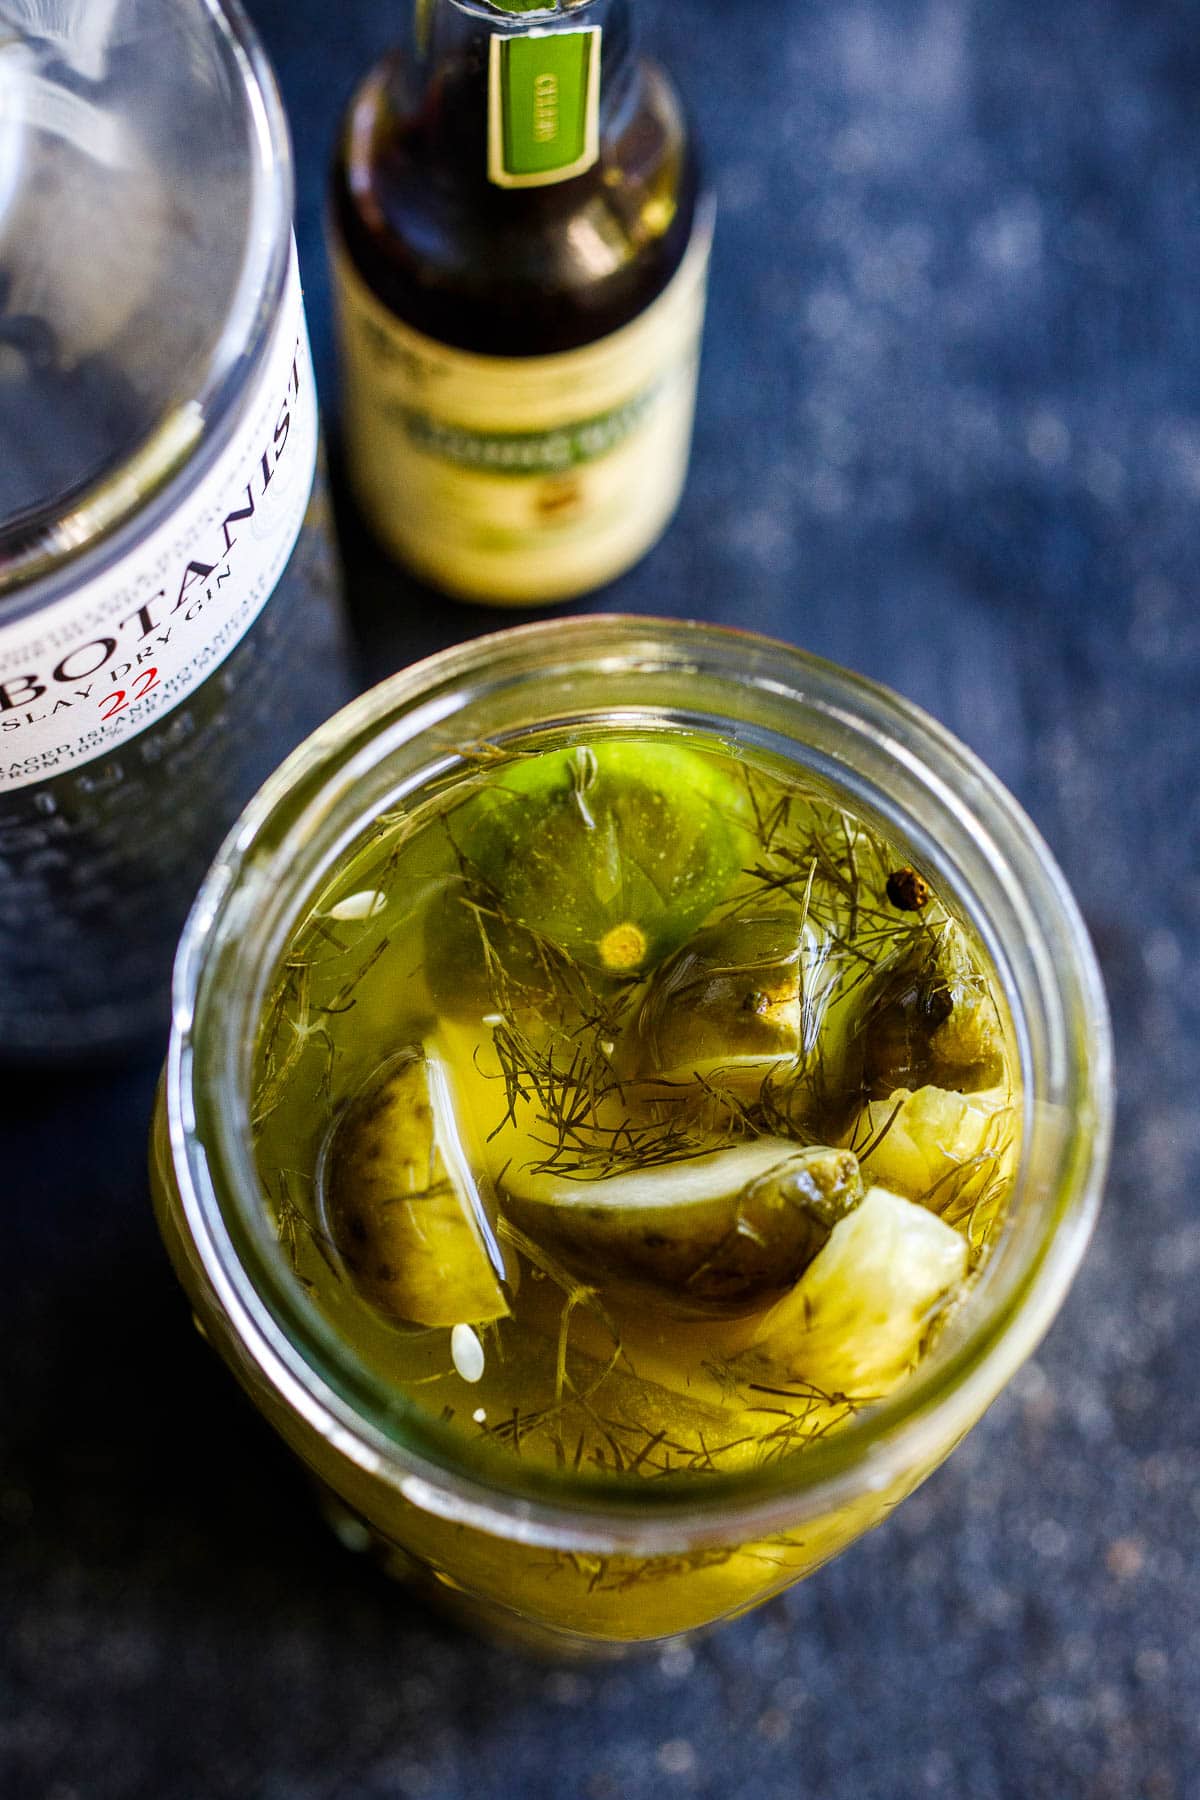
[336,216,712,605]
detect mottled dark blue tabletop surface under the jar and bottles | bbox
[0,0,1200,1800]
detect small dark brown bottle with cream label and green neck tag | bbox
[331,0,712,605]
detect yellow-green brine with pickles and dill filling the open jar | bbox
[254,733,1020,1519]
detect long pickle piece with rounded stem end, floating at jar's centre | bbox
[500,1138,864,1314]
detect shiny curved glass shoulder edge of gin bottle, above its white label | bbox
[0,0,295,604]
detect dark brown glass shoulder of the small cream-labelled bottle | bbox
[331,59,700,356]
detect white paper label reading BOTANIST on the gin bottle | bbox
[0,245,317,792]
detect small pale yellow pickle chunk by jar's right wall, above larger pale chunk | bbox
[851,1087,1016,1211]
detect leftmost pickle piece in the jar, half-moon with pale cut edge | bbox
[326,1046,509,1327]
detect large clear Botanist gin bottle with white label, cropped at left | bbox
[0,0,351,1058]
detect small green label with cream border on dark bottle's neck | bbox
[488,25,601,187]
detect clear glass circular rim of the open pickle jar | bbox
[167,617,1112,1553]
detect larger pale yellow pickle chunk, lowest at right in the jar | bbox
[754,1188,966,1399]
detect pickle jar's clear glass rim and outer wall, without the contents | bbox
[151,617,1112,1651]
